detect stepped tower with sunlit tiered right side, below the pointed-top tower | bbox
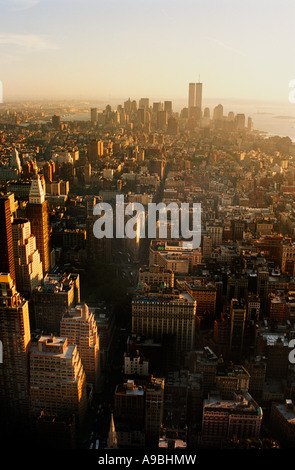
[12,219,43,295]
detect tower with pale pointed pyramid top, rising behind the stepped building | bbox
[27,175,51,274]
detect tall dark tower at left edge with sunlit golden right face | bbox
[0,273,31,418]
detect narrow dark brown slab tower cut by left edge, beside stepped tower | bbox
[0,195,15,281]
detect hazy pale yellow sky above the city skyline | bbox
[0,0,295,102]
